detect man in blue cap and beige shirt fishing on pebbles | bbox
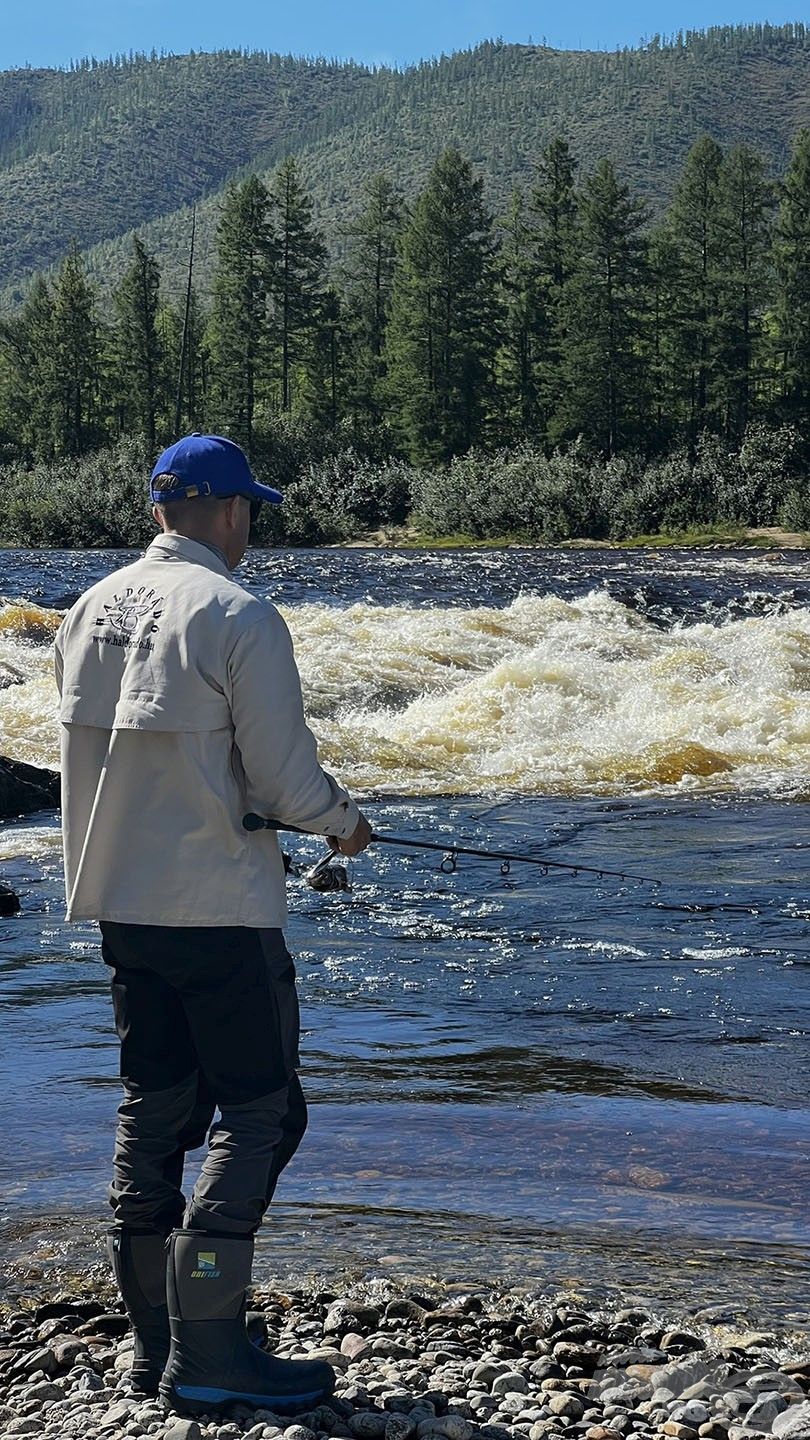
[56,435,370,1414]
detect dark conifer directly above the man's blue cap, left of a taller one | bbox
[208,176,275,451]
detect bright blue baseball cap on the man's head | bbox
[148,432,282,505]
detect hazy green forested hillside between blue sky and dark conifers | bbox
[0,24,810,307]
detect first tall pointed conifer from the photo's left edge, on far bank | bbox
[52,245,101,455]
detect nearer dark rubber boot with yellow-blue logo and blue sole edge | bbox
[160,1230,334,1416]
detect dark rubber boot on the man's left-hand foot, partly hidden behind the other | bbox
[107,1227,169,1395]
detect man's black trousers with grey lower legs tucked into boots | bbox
[101,922,307,1234]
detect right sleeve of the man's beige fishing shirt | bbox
[228,605,360,840]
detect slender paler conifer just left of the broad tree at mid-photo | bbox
[342,174,404,419]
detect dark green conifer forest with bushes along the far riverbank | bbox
[0,28,810,546]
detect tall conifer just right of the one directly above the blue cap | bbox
[270,157,326,410]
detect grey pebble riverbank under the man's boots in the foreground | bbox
[0,1276,810,1440]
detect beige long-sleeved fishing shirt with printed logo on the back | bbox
[56,536,359,927]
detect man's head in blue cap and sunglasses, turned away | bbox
[150,435,281,569]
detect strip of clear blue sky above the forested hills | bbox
[0,0,810,69]
